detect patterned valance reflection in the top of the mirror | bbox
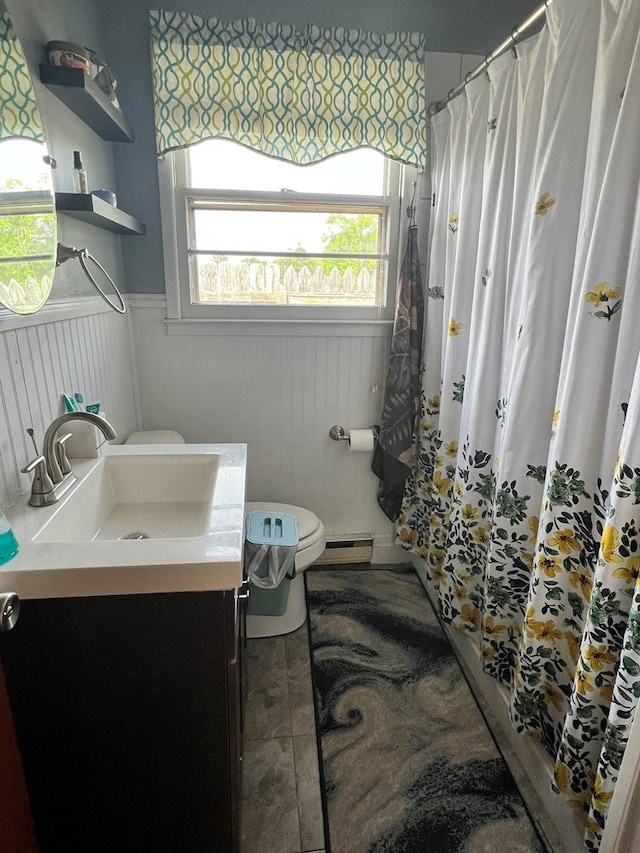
[0,12,44,142]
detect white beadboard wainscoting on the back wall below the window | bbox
[131,302,393,535]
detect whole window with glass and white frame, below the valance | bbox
[160,139,407,321]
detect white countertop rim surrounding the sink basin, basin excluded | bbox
[0,444,247,599]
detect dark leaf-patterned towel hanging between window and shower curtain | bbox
[371,225,424,521]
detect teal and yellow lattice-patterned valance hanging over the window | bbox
[150,12,426,168]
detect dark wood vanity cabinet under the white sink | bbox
[0,590,244,853]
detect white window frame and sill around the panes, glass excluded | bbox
[158,149,417,333]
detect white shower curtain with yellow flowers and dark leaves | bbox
[398,0,640,850]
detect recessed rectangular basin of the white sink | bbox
[34,454,220,542]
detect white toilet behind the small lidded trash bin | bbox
[126,430,326,638]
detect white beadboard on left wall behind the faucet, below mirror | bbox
[0,308,137,506]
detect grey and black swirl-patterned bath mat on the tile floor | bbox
[305,567,547,853]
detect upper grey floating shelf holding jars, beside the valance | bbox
[40,63,134,142]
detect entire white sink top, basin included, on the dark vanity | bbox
[0,444,247,599]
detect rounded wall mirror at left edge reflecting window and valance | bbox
[0,0,57,314]
